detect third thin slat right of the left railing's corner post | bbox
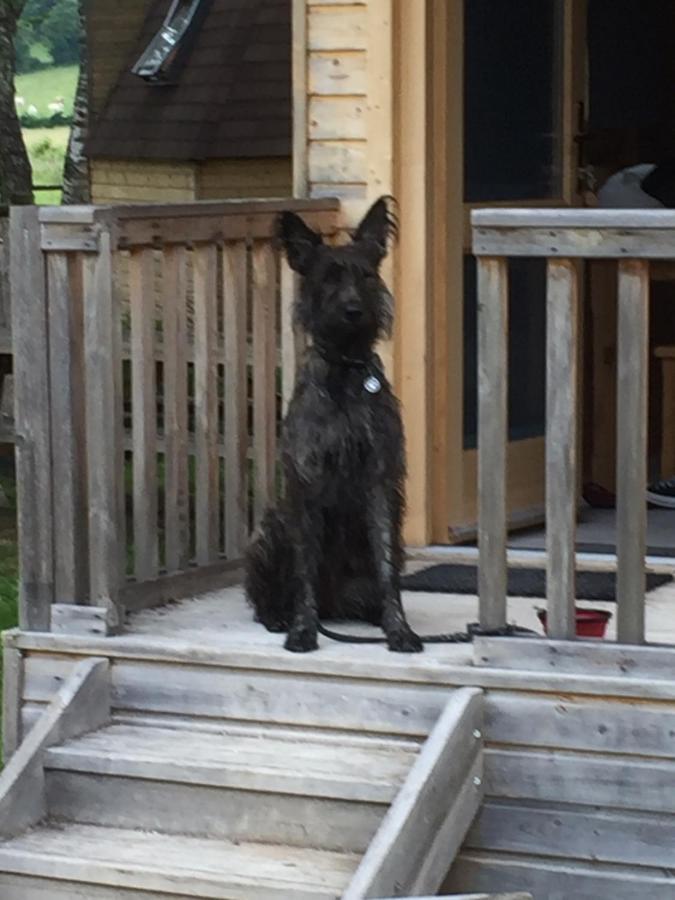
[194,244,220,565]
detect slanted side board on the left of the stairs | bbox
[0,658,110,838]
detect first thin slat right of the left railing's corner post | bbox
[129,250,159,581]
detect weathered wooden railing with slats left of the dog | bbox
[11,200,338,633]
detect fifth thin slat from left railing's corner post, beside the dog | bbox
[253,241,277,525]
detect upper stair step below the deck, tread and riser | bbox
[45,723,417,852]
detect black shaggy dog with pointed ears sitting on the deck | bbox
[246,197,422,653]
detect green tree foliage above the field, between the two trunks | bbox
[16,0,80,72]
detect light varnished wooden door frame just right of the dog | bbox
[394,0,587,546]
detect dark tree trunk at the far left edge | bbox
[0,0,33,342]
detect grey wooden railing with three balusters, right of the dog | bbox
[472,209,675,644]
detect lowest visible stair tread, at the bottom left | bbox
[0,823,360,898]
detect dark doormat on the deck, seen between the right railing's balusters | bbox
[401,563,673,602]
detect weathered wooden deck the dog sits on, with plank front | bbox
[6,587,675,900]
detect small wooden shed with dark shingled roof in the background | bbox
[86,0,292,203]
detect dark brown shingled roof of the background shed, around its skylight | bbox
[87,0,292,160]
